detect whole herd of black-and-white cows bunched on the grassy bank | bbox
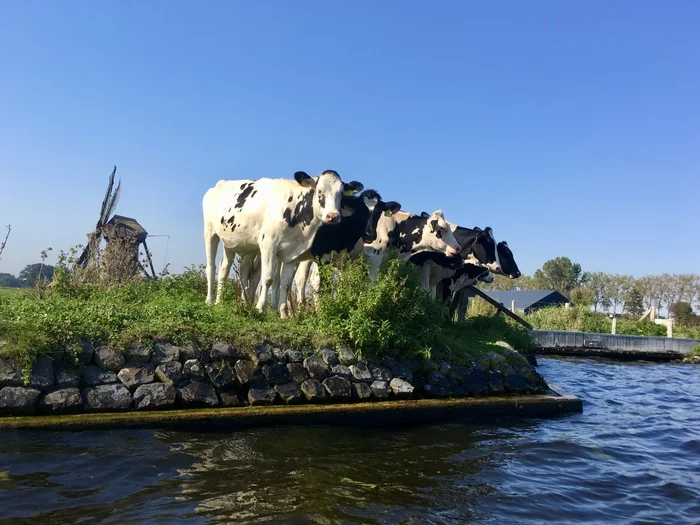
[202,170,520,317]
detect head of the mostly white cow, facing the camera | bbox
[294,170,363,224]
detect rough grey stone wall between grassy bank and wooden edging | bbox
[0,342,548,416]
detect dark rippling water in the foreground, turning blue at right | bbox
[0,359,700,524]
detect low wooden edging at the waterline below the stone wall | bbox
[0,387,583,431]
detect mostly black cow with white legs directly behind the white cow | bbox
[294,190,401,303]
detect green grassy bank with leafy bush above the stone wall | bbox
[0,260,531,370]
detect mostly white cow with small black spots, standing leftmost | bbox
[202,170,363,315]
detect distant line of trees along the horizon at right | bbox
[481,257,700,326]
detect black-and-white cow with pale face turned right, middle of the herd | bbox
[364,210,461,280]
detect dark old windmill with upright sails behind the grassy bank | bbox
[78,166,156,279]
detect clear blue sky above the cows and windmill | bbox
[0,0,700,276]
